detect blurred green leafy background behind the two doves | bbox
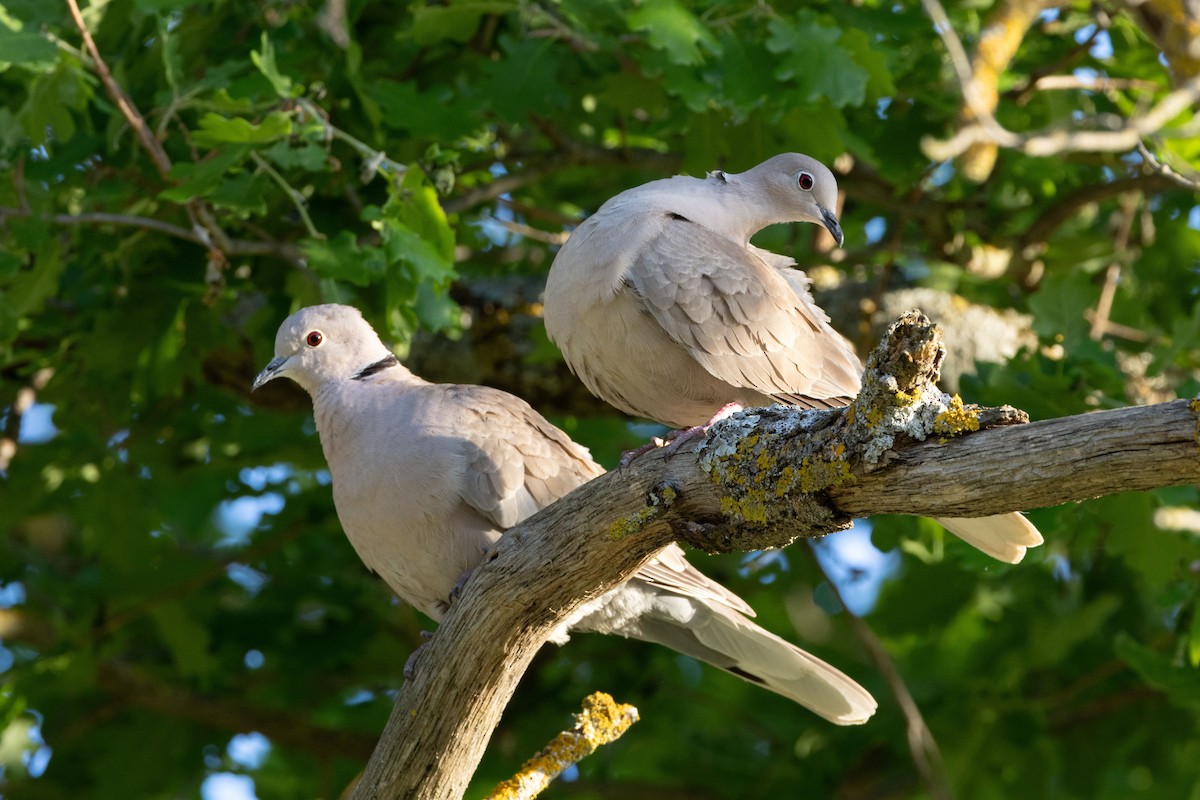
[0,0,1200,800]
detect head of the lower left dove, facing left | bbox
[253,305,398,395]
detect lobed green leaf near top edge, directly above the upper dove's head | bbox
[767,14,868,108]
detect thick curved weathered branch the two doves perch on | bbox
[353,313,1200,800]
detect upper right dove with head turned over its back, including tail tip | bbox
[545,154,1042,564]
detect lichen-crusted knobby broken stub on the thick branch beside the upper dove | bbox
[677,311,1028,553]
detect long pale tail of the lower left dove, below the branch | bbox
[622,599,876,724]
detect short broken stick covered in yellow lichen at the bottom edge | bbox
[488,692,637,800]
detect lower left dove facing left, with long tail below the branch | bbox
[253,305,876,724]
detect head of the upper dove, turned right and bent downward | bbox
[743,152,845,247]
